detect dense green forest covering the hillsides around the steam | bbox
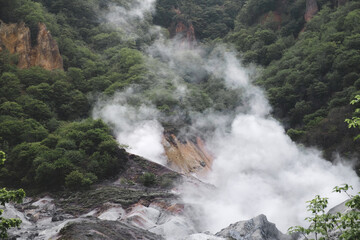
[0,0,360,195]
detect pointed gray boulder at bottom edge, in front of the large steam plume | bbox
[216,214,292,240]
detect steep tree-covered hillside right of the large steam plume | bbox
[253,1,360,158]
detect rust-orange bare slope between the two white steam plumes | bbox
[163,135,213,175]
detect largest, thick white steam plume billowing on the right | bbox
[185,54,360,232]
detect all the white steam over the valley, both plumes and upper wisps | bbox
[94,0,360,236]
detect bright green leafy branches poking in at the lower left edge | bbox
[0,151,25,239]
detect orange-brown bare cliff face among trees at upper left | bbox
[0,22,63,70]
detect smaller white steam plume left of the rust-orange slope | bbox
[93,89,166,165]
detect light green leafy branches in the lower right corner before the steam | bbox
[288,184,360,240]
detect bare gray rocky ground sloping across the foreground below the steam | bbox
[5,154,291,240]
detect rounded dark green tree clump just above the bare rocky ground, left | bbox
[28,119,124,189]
